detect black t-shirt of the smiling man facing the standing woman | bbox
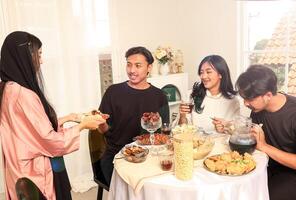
[99,82,169,154]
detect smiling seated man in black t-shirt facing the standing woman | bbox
[99,47,169,185]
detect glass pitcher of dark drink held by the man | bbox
[229,116,257,155]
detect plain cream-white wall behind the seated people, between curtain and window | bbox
[110,0,237,88]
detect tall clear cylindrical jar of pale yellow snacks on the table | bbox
[173,132,193,180]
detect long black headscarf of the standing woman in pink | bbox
[0,31,58,130]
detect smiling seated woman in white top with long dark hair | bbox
[180,55,240,131]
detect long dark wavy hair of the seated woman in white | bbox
[191,55,237,113]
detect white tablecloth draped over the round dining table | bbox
[108,135,269,200]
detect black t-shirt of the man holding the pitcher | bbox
[251,95,296,168]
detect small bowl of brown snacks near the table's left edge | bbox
[121,144,149,163]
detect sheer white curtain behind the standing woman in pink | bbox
[0,0,105,192]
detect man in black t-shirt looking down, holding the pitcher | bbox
[236,65,296,200]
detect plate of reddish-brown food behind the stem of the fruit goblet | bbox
[134,133,170,145]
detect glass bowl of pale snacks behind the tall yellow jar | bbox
[193,134,215,160]
